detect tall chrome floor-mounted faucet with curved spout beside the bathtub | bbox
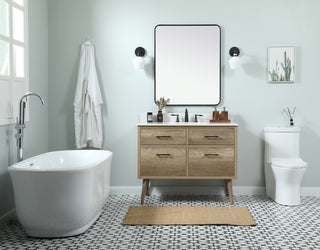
[15,92,44,162]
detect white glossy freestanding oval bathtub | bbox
[9,150,112,237]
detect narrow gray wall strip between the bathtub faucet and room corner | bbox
[24,0,49,157]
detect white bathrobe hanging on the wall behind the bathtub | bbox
[73,41,103,149]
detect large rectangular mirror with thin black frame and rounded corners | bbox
[154,25,221,106]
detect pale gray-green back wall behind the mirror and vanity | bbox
[48,0,320,186]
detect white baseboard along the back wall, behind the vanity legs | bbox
[110,186,320,197]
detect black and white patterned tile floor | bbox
[0,195,320,250]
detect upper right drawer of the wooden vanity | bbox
[188,127,235,145]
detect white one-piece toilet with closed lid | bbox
[264,127,307,206]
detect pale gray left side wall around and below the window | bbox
[0,0,48,217]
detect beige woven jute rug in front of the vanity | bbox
[122,206,256,226]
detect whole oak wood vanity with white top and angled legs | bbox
[138,122,238,204]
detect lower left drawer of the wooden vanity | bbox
[139,147,186,176]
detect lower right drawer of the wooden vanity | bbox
[188,147,235,176]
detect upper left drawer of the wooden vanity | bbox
[140,128,187,145]
